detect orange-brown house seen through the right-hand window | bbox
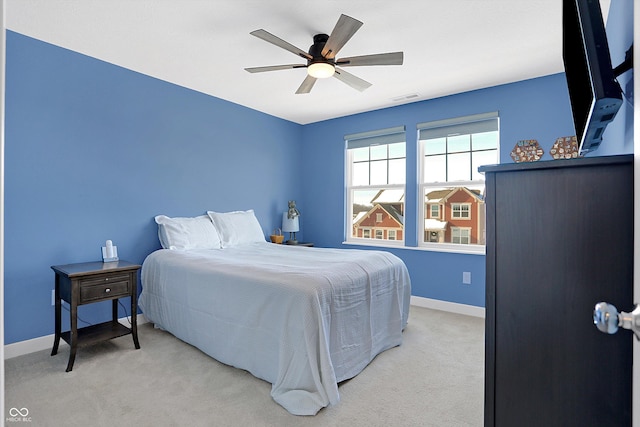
[424,187,485,245]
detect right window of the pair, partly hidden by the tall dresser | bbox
[418,113,499,252]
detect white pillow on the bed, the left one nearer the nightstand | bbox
[155,215,221,250]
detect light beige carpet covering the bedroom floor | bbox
[4,306,484,427]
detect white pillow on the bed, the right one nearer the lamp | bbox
[207,209,266,248]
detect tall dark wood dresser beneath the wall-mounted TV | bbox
[480,155,634,427]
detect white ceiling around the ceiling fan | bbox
[5,0,608,124]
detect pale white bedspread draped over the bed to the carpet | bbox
[140,242,411,415]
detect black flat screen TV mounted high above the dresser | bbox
[562,0,622,154]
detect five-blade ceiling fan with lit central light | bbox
[245,15,404,94]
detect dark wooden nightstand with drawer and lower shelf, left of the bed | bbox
[51,261,140,372]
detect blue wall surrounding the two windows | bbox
[302,74,575,307]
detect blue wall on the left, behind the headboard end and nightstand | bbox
[4,31,302,344]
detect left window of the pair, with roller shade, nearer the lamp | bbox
[345,126,406,244]
